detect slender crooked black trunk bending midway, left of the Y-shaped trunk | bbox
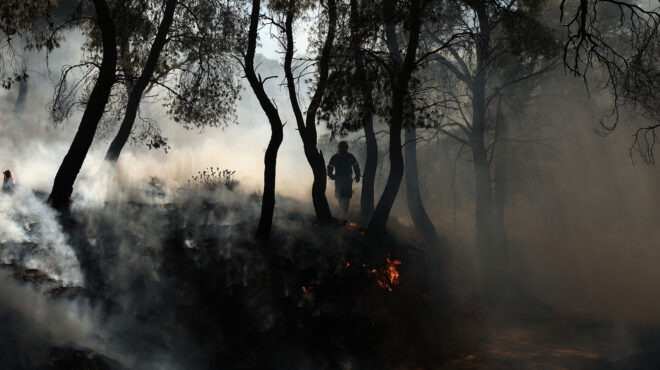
[243,0,284,242]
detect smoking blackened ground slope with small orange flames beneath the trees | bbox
[0,178,660,369]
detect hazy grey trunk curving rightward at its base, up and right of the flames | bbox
[403,127,440,244]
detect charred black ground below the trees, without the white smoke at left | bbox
[0,204,660,369]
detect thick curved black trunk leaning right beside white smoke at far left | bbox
[48,0,117,209]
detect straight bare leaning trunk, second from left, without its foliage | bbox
[105,0,177,163]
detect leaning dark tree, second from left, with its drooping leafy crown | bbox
[106,0,245,162]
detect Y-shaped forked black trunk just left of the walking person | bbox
[284,0,337,224]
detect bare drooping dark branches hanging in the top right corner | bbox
[561,0,660,164]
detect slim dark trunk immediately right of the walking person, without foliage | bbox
[351,0,378,222]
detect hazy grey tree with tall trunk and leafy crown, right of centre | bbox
[428,0,556,267]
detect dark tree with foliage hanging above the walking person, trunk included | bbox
[319,0,384,223]
